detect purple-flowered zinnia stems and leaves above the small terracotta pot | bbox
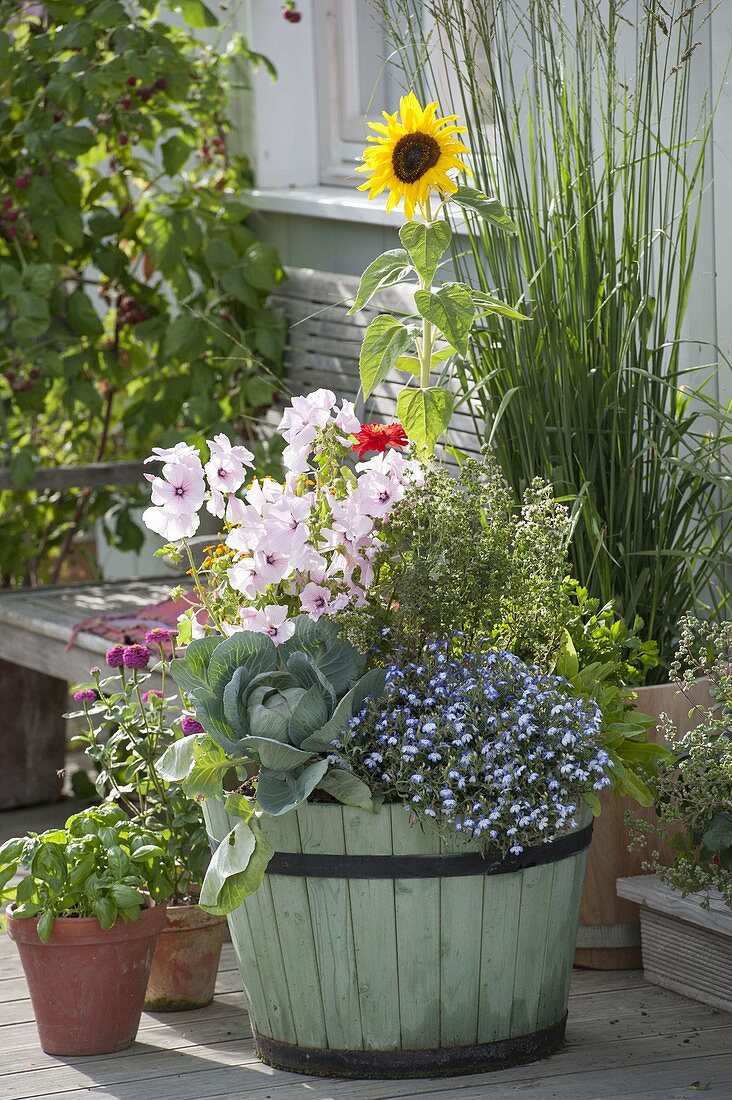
[66,628,210,904]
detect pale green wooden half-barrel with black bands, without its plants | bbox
[205,802,592,1078]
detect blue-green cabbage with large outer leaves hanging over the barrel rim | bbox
[157,615,385,913]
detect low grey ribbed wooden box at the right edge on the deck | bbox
[618,875,732,1012]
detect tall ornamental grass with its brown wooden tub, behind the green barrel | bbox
[380,0,732,968]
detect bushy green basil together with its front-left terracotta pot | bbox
[0,805,172,1056]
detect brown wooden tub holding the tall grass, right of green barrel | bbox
[575,680,709,970]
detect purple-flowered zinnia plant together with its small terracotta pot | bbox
[67,628,226,1012]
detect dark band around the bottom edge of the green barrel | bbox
[254,1016,567,1078]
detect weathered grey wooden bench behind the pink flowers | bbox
[0,268,479,809]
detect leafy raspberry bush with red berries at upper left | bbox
[0,0,284,586]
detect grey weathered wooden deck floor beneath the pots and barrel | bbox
[0,936,732,1100]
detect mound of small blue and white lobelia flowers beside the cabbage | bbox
[339,641,610,855]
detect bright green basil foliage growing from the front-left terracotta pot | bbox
[0,805,173,943]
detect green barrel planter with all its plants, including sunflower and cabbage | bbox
[137,95,669,1077]
